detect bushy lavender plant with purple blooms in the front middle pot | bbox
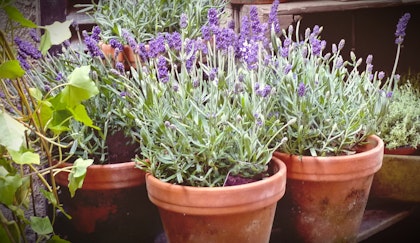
[121,3,293,187]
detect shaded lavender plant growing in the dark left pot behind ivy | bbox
[28,26,142,164]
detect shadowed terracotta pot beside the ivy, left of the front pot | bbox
[55,162,162,242]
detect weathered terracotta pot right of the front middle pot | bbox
[274,136,384,243]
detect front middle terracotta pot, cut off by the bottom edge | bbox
[146,158,286,243]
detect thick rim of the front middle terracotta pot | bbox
[146,157,286,215]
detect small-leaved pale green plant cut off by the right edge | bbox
[379,81,420,149]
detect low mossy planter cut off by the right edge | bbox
[370,154,420,203]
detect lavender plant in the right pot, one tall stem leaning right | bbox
[270,11,410,156]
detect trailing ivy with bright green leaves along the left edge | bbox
[0,1,98,242]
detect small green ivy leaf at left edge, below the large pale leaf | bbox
[0,174,22,206]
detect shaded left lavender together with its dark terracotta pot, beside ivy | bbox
[22,27,161,242]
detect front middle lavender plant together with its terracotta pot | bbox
[116,4,293,242]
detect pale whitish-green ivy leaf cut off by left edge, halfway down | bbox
[0,109,27,151]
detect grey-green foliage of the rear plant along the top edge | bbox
[76,0,226,43]
